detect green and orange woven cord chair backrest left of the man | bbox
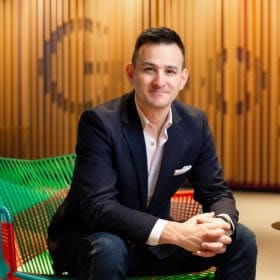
[0,154,75,274]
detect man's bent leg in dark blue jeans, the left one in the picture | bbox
[74,232,127,280]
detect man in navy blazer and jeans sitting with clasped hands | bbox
[49,25,257,280]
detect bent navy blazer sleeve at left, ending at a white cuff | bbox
[71,111,157,243]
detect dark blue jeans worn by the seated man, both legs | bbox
[73,224,257,280]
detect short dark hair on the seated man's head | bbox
[131,27,185,68]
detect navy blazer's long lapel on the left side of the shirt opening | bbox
[122,94,148,209]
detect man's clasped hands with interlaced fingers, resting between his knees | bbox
[160,212,232,257]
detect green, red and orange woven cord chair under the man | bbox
[0,154,214,280]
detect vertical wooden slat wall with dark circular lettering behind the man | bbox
[0,0,280,190]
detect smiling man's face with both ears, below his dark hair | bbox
[126,44,188,113]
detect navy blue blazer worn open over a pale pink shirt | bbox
[48,92,238,271]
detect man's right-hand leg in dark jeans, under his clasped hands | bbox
[128,224,257,280]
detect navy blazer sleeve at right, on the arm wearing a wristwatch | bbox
[188,113,238,228]
